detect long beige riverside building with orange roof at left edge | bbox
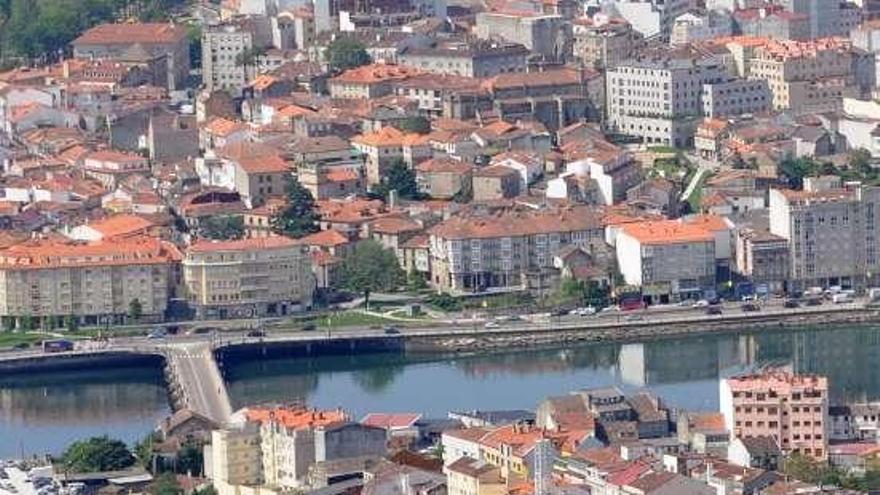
[0,237,181,325]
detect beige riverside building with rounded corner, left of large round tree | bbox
[183,236,315,318]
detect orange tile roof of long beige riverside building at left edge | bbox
[0,237,181,270]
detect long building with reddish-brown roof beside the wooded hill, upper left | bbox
[71,23,190,89]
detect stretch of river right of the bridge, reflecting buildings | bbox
[227,328,880,415]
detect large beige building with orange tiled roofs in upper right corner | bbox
[749,38,856,115]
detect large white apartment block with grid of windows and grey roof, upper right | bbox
[606,48,729,147]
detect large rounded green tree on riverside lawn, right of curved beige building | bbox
[341,240,405,307]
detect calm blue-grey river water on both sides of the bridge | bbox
[0,328,880,457]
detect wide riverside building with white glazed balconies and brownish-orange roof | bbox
[428,206,604,292]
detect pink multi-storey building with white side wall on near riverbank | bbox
[720,370,828,459]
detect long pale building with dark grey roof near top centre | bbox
[397,40,529,77]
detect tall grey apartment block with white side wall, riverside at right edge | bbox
[770,178,880,290]
